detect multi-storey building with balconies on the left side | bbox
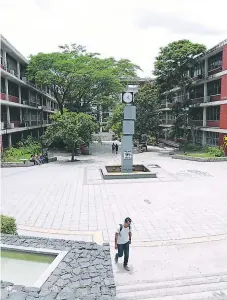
[0,35,58,148]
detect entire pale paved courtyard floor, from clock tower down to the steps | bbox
[1,143,227,300]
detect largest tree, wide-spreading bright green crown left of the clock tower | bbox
[27,44,140,113]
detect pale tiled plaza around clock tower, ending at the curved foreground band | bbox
[1,144,227,242]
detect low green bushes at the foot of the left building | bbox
[2,136,41,162]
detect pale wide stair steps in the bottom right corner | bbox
[117,274,227,300]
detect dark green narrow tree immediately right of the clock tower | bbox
[135,82,159,142]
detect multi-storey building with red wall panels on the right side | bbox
[160,40,227,152]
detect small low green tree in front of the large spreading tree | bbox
[43,110,97,161]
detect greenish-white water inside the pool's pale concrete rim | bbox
[1,249,56,286]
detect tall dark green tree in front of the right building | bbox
[154,40,206,139]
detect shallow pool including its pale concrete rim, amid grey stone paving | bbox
[0,244,67,288]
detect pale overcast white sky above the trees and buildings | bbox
[0,0,227,76]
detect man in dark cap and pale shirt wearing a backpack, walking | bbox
[115,218,132,271]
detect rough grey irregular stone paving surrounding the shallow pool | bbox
[1,234,116,300]
